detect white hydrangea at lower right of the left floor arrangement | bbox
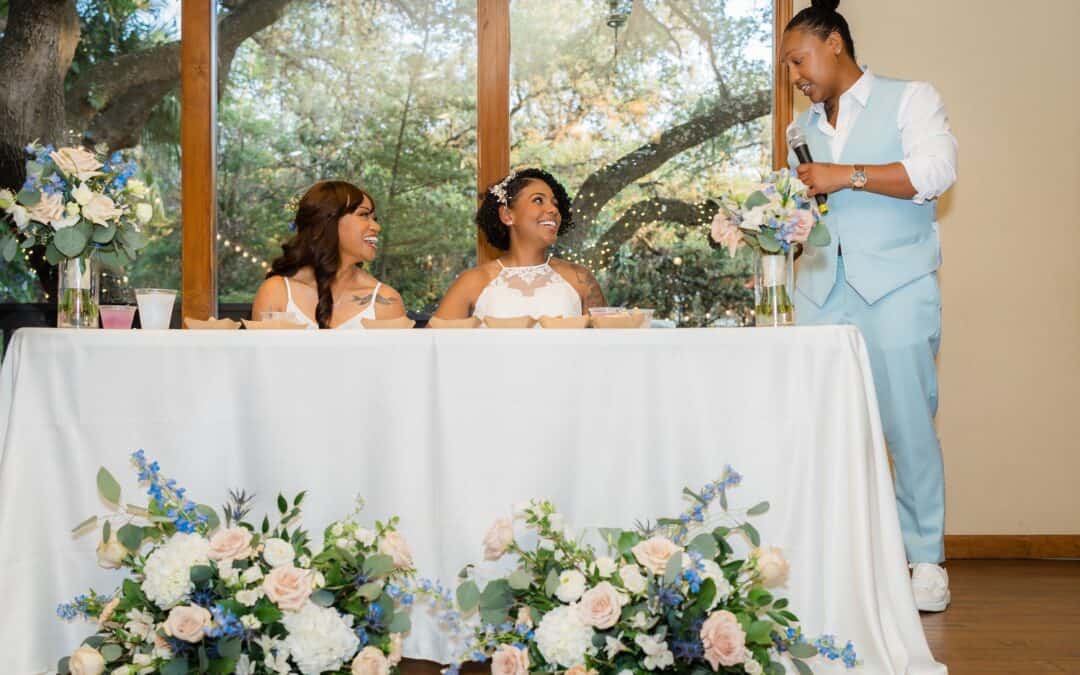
[282,603,360,675]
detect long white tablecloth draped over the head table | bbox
[0,327,945,675]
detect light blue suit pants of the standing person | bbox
[795,256,945,563]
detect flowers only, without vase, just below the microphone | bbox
[711,168,831,256]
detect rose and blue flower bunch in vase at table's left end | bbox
[0,143,153,268]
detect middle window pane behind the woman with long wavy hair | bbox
[218,0,476,309]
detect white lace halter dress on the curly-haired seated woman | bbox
[473,258,581,319]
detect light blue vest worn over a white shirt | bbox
[791,76,941,307]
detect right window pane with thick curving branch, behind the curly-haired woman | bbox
[511,0,772,325]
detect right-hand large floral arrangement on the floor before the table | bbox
[457,468,858,675]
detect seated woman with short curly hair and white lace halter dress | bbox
[434,168,605,319]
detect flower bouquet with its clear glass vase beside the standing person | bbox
[710,168,831,326]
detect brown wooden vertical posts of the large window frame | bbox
[180,0,794,308]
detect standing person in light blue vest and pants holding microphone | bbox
[781,0,957,611]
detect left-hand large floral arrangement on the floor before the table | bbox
[57,450,414,675]
